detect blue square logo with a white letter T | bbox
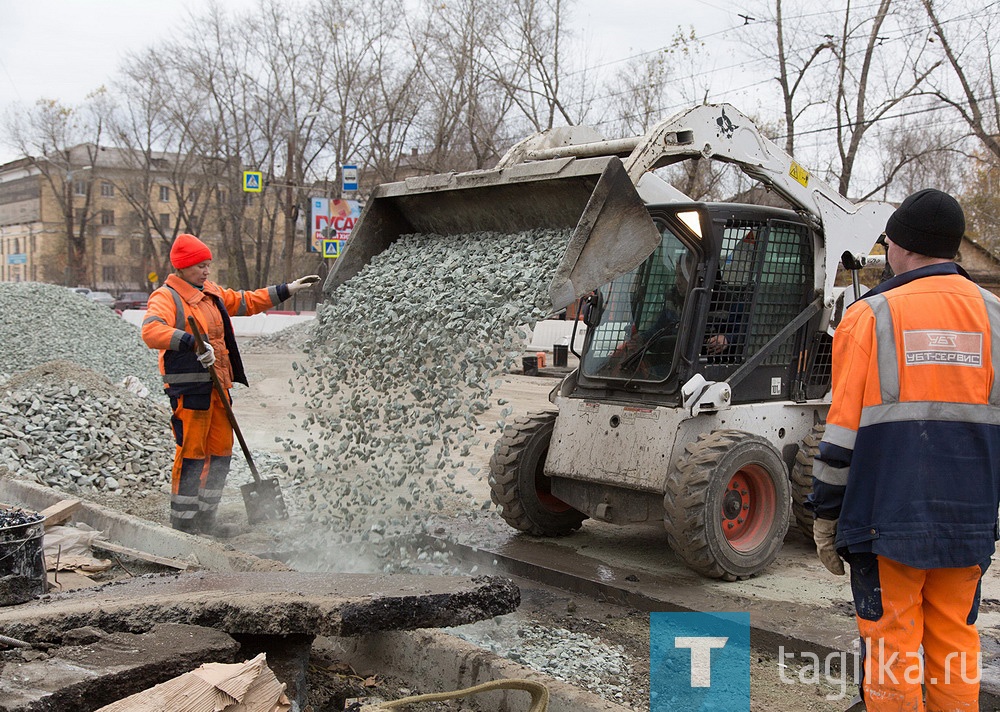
[649,613,750,712]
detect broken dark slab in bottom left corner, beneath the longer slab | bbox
[0,624,239,712]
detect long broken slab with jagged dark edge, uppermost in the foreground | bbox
[0,572,520,642]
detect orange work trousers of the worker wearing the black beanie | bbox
[851,555,985,712]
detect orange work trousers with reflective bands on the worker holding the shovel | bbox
[170,389,233,532]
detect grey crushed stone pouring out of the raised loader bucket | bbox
[276,230,569,570]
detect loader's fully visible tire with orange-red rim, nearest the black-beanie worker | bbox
[663,430,790,581]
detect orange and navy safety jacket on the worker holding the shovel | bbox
[142,274,289,397]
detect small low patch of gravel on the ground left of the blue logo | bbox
[448,621,633,704]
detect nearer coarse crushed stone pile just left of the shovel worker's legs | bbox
[0,361,174,511]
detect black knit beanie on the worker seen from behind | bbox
[885,188,965,259]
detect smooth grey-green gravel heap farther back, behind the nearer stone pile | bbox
[0,282,163,394]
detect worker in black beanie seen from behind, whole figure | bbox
[810,190,1000,712]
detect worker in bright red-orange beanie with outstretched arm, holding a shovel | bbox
[142,234,319,535]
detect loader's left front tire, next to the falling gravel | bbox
[490,412,587,536]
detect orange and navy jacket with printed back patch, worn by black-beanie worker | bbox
[813,263,1000,568]
